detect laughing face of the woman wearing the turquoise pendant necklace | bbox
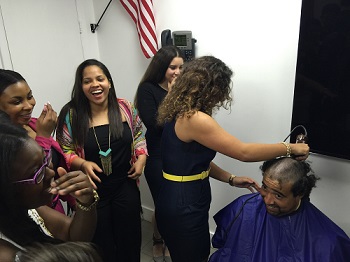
[82,65,110,105]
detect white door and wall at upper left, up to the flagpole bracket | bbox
[0,0,99,116]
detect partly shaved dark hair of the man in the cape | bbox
[260,157,320,200]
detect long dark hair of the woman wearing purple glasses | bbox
[0,111,61,246]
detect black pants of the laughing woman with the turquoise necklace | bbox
[92,178,141,262]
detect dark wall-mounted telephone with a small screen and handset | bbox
[161,29,197,61]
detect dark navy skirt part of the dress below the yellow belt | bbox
[156,178,211,262]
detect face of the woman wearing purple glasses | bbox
[12,138,55,209]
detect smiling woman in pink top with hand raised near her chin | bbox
[0,69,75,213]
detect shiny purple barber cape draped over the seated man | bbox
[209,193,350,262]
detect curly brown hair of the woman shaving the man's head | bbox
[157,56,233,126]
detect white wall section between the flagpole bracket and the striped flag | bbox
[93,0,149,100]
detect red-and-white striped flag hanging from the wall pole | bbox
[120,0,158,58]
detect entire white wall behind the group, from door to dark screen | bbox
[0,0,350,235]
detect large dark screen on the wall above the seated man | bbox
[291,0,350,159]
